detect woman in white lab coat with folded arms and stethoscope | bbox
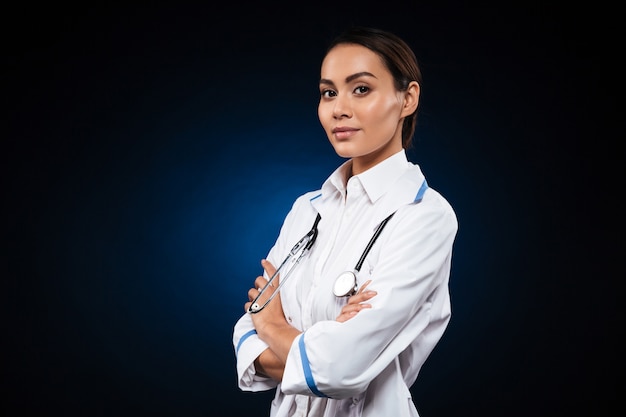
[233,28,458,417]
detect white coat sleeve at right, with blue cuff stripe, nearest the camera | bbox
[281,190,458,399]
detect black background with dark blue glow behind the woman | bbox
[0,2,624,417]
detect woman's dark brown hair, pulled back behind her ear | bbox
[326,26,422,148]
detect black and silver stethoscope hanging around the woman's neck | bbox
[248,180,428,314]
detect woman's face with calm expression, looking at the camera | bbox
[318,44,412,175]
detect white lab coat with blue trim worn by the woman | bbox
[233,150,458,417]
